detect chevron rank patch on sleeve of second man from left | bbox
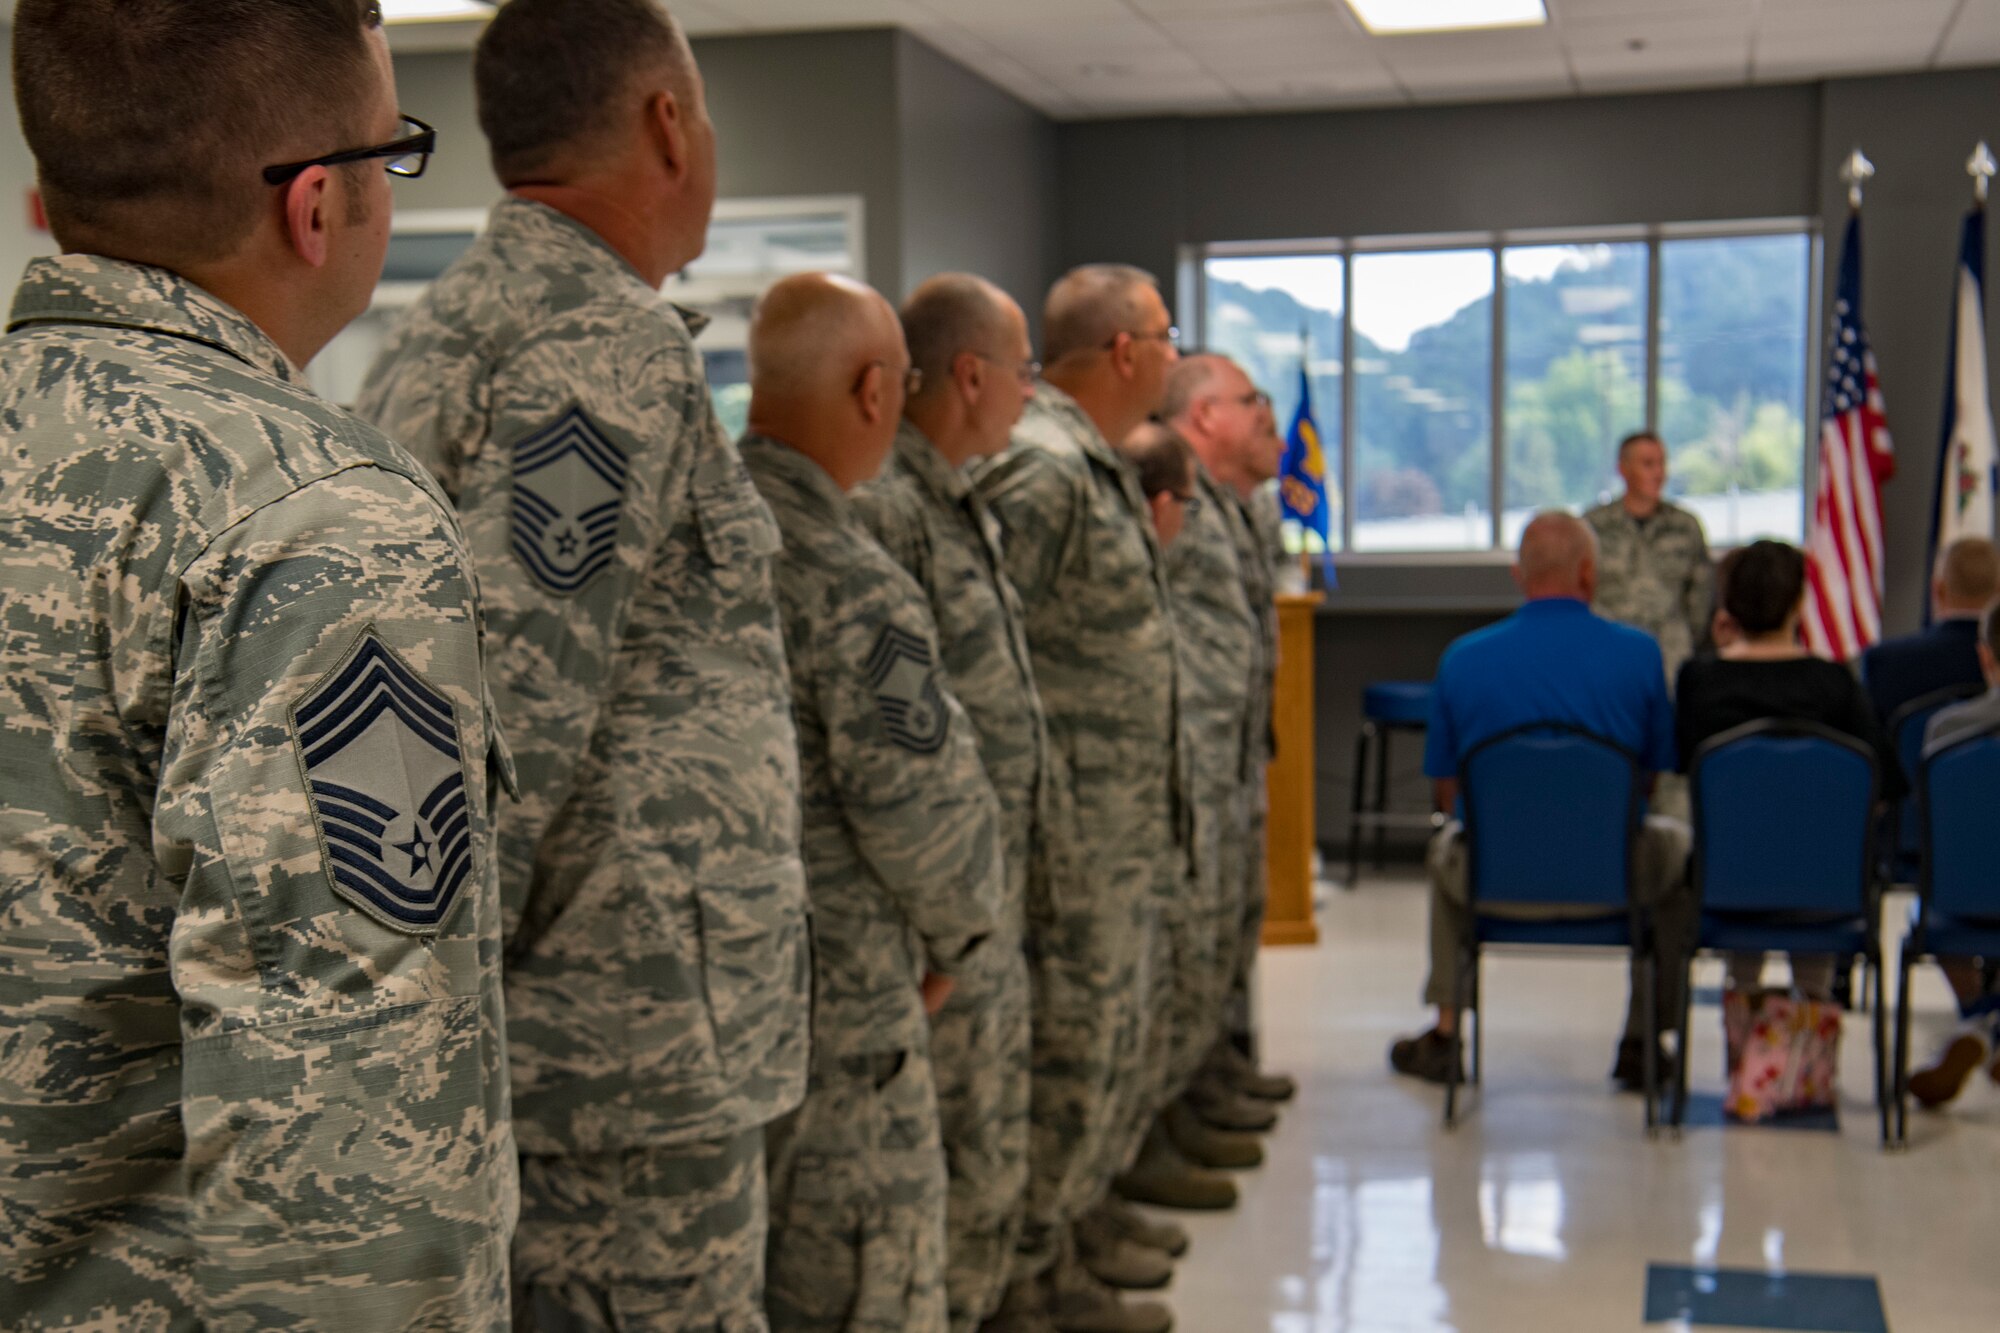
[512,408,628,596]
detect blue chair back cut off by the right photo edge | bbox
[1916,731,2000,921]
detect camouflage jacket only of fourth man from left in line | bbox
[852,422,1060,921]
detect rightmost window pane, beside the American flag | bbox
[1660,236,1812,546]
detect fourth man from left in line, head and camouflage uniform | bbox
[854,274,1066,1333]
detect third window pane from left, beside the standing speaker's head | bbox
[1500,244,1646,546]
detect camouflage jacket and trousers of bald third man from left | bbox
[742,436,1004,1333]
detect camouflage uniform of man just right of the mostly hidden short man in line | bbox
[1154,464,1262,1099]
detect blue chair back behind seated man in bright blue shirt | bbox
[1458,723,1640,911]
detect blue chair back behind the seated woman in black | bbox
[1688,719,1882,919]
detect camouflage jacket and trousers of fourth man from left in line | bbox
[854,422,1058,1333]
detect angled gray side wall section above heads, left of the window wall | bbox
[896,34,1056,324]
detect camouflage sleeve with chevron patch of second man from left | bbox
[460,306,696,941]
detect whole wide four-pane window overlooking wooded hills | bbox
[1192,222,1814,554]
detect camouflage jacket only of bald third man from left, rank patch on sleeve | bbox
[742,434,1002,1063]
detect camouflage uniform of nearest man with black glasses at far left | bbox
[0,256,516,1331]
